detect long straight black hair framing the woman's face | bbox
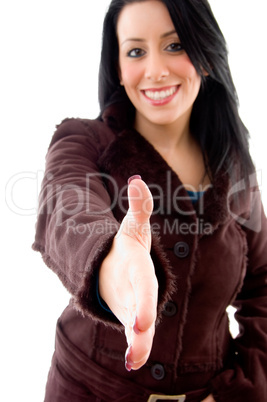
[99,0,254,180]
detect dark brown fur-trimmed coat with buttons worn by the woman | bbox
[33,106,267,402]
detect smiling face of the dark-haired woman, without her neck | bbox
[117,0,201,133]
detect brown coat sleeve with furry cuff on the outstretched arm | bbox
[33,119,122,326]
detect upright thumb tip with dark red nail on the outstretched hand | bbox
[128,175,153,225]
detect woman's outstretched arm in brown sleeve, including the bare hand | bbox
[33,119,158,369]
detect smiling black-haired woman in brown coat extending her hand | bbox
[33,0,267,402]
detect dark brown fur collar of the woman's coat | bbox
[99,105,249,230]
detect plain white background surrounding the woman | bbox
[0,0,267,402]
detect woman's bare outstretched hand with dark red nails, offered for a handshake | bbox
[99,176,158,371]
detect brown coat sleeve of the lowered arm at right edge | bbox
[212,191,267,402]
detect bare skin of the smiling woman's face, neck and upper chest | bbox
[117,1,209,189]
